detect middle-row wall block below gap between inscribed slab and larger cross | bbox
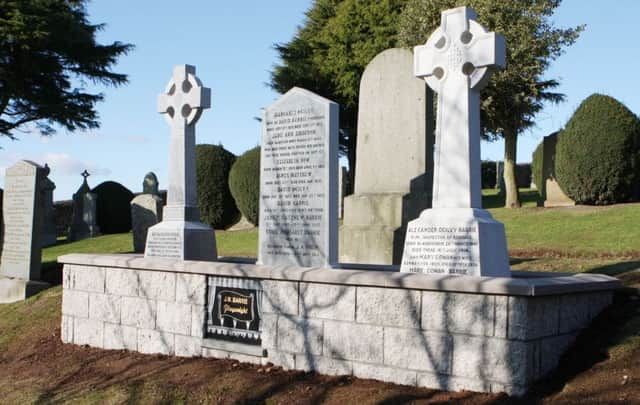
[322,321,383,363]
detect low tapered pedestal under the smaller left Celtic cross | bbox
[144,221,218,261]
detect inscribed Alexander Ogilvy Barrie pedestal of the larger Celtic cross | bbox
[400,208,511,277]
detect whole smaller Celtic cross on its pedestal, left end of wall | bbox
[144,65,218,260]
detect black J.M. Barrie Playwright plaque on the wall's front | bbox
[206,277,262,345]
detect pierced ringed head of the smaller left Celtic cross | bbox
[158,65,211,125]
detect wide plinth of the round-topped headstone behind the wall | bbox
[338,192,431,264]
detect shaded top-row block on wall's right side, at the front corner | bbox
[509,296,560,340]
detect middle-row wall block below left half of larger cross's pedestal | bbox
[384,328,453,373]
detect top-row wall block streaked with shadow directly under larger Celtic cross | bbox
[422,291,495,336]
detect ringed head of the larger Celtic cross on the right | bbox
[414,7,506,93]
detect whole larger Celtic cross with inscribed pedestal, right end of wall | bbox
[401,7,511,277]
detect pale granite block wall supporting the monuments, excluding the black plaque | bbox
[62,258,612,395]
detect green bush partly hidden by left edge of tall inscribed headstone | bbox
[229,146,260,226]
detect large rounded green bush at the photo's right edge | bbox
[555,94,640,204]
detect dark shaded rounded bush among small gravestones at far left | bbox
[91,181,133,234]
